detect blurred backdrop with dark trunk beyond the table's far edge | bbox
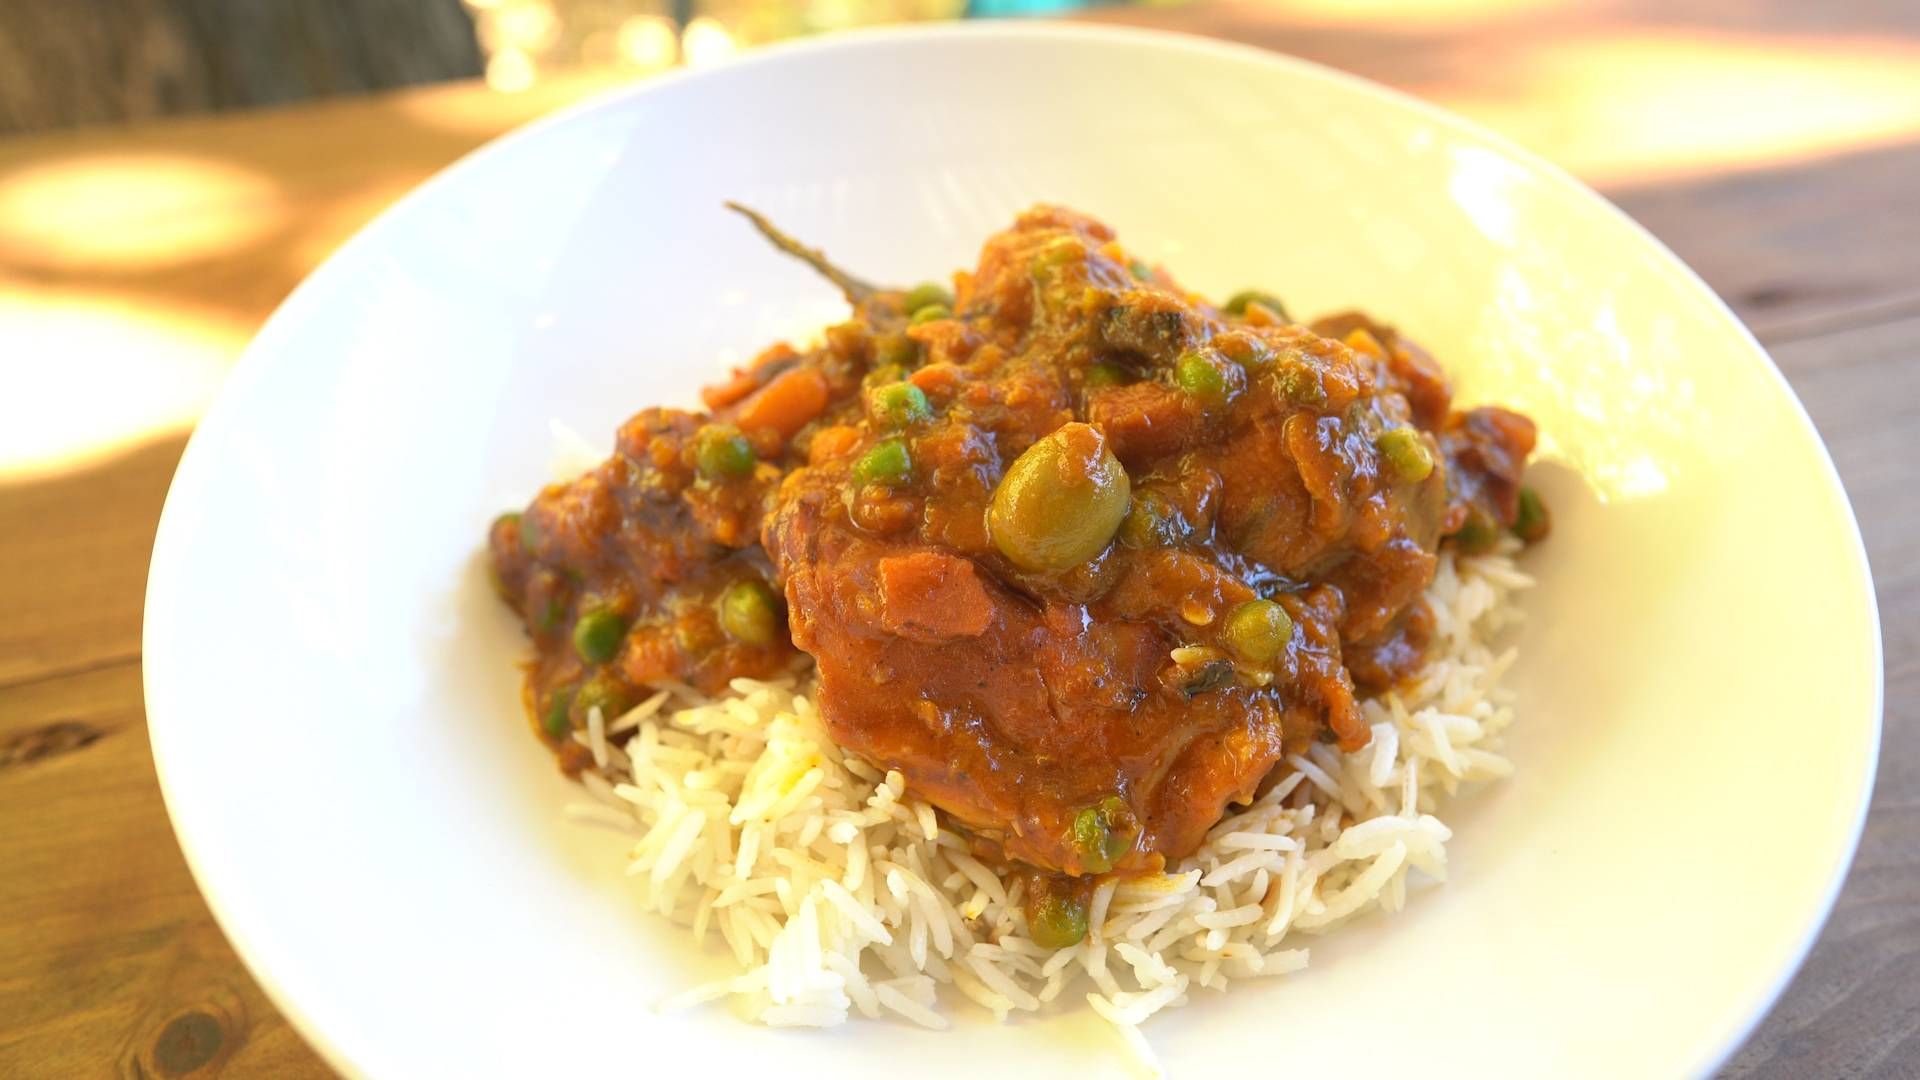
[0,0,1128,131]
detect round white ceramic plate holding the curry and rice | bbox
[146,27,1880,1078]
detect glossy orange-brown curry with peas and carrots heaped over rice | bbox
[492,208,1534,896]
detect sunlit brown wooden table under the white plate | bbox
[0,0,1920,1078]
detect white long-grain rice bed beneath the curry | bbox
[574,540,1530,1072]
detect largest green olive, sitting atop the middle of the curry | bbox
[987,423,1133,573]
